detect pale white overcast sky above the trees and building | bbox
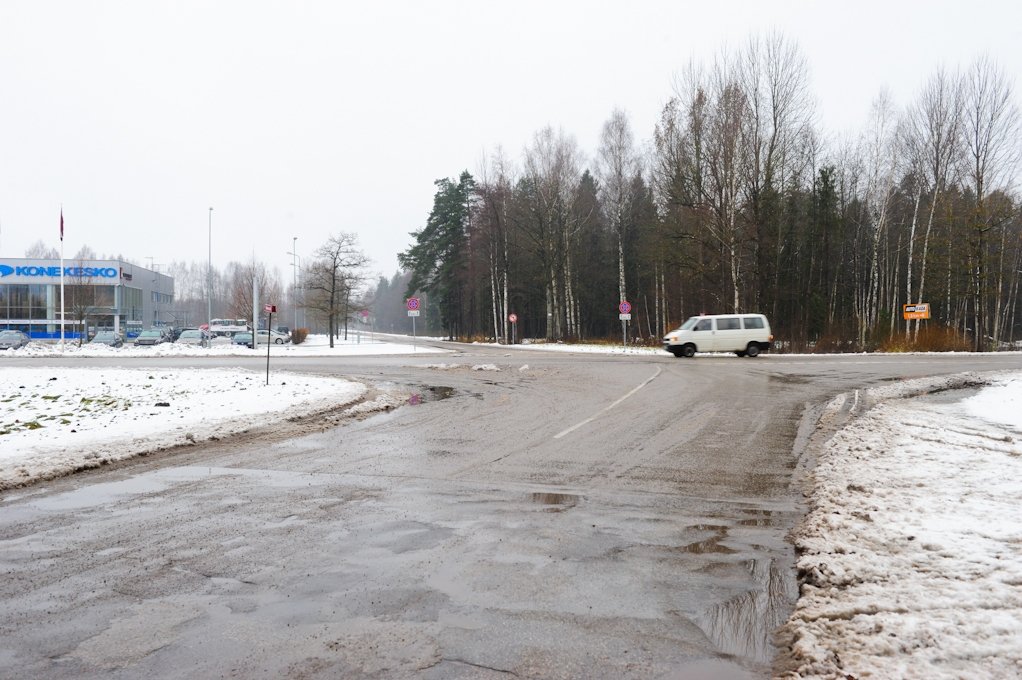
[0,0,1022,282]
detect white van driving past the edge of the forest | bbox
[663,314,774,357]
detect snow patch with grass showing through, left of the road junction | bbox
[0,366,366,489]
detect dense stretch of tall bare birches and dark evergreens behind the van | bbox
[394,34,1022,350]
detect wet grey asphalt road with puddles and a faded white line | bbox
[0,347,1022,678]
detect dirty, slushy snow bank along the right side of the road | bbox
[781,375,1022,679]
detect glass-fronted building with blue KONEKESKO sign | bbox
[0,258,173,338]
